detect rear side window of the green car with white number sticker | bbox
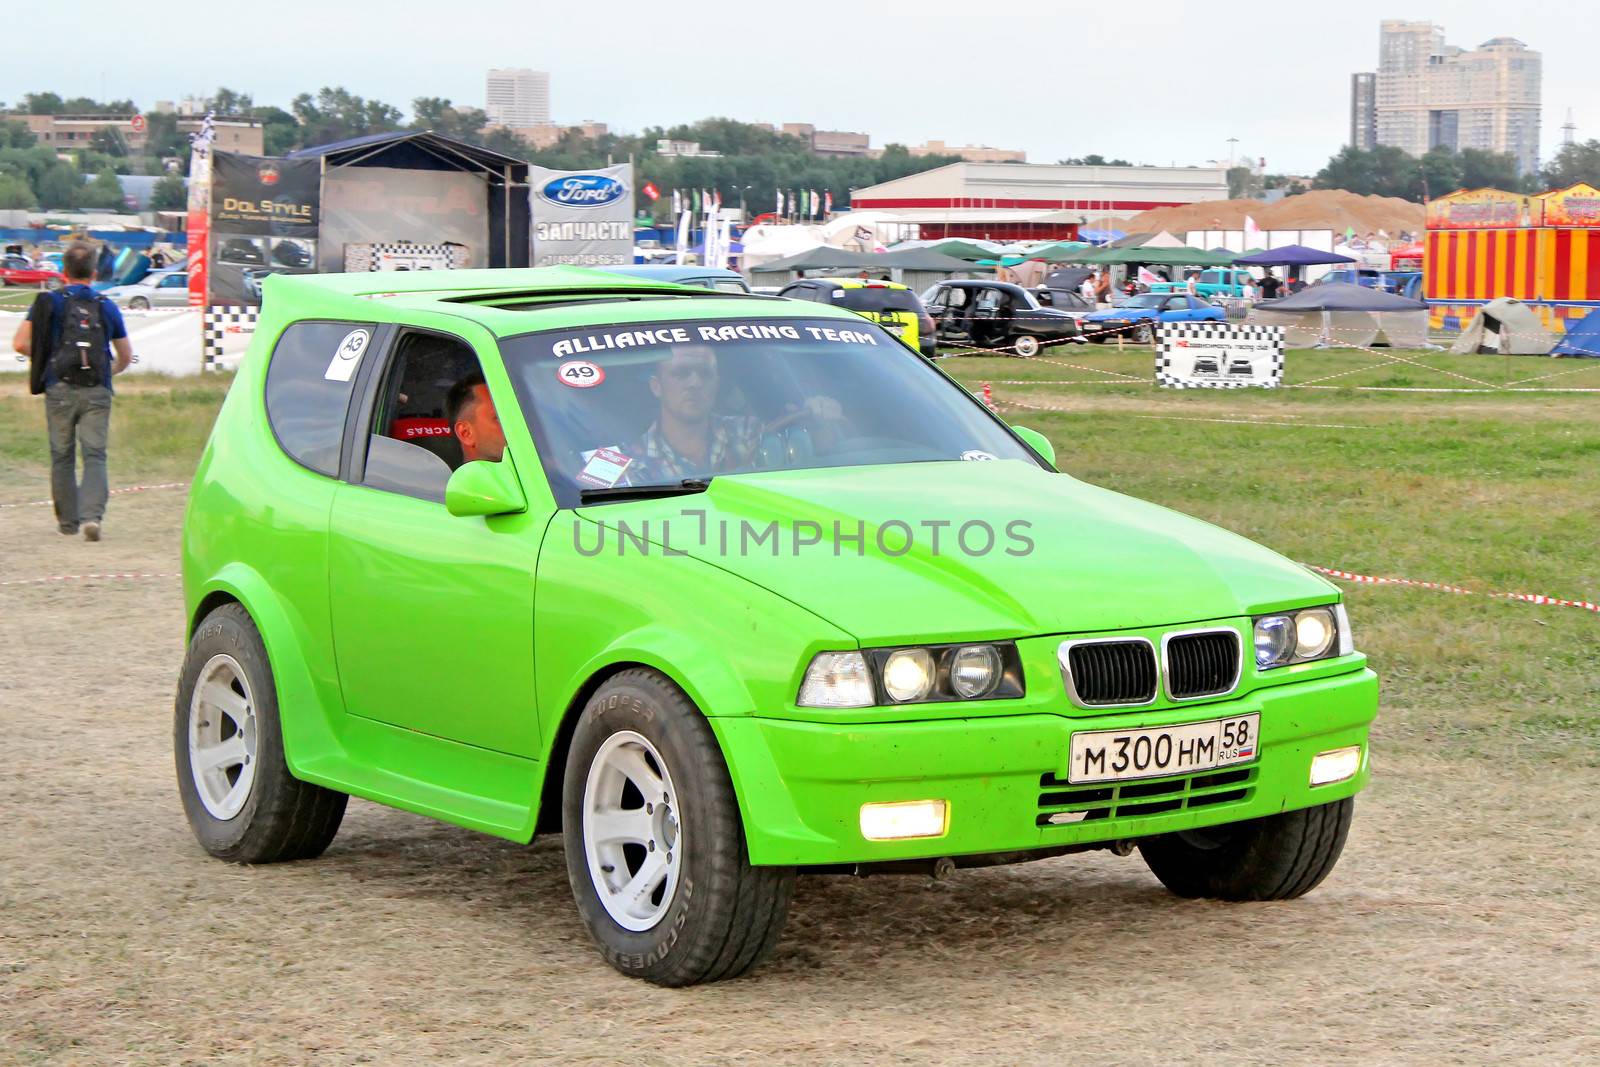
[266,322,374,478]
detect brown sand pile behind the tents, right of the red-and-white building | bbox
[1088,189,1427,237]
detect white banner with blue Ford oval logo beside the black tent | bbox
[528,163,634,267]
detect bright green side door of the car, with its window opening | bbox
[328,321,549,757]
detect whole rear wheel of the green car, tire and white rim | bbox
[173,603,347,864]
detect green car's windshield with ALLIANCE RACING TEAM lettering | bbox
[501,318,1037,507]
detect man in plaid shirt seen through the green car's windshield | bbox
[627,344,843,485]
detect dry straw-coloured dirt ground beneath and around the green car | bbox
[0,478,1600,1064]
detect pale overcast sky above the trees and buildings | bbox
[9,0,1600,174]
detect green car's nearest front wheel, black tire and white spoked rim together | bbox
[562,669,795,985]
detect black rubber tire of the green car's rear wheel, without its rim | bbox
[173,603,349,864]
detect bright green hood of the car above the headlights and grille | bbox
[581,461,1336,645]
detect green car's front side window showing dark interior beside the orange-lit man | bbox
[362,331,486,502]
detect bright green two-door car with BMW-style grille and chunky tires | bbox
[173,267,1378,985]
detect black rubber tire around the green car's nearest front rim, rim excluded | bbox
[562,669,795,985]
